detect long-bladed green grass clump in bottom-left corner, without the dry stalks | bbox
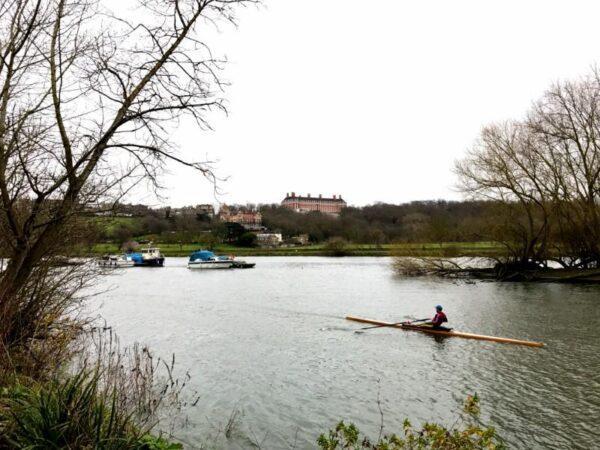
[0,371,182,449]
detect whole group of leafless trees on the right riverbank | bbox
[455,70,600,268]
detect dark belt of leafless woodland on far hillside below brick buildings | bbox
[95,200,506,245]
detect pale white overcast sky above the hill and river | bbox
[142,0,600,206]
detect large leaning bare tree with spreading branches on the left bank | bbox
[0,0,255,370]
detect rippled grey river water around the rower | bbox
[93,257,600,449]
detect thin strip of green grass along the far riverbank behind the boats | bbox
[91,242,502,257]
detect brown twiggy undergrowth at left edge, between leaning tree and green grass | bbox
[0,258,98,381]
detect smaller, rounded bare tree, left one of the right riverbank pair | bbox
[455,122,551,266]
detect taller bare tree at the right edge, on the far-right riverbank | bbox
[527,69,600,267]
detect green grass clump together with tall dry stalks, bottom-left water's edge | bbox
[0,327,191,450]
